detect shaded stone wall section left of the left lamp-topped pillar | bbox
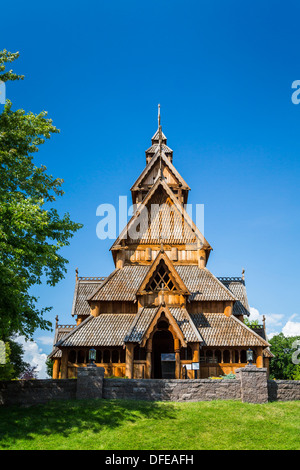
[0,379,77,405]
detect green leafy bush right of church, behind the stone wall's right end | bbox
[269,333,300,380]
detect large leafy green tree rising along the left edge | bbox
[0,50,82,339]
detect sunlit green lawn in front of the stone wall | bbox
[0,400,300,450]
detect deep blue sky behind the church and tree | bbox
[0,0,300,374]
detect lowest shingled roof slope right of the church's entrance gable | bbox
[191,313,269,347]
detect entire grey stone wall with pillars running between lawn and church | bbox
[0,366,300,405]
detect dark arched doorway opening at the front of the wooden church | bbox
[152,325,175,379]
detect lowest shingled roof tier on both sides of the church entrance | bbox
[52,307,272,357]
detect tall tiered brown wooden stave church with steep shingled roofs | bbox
[49,112,273,379]
